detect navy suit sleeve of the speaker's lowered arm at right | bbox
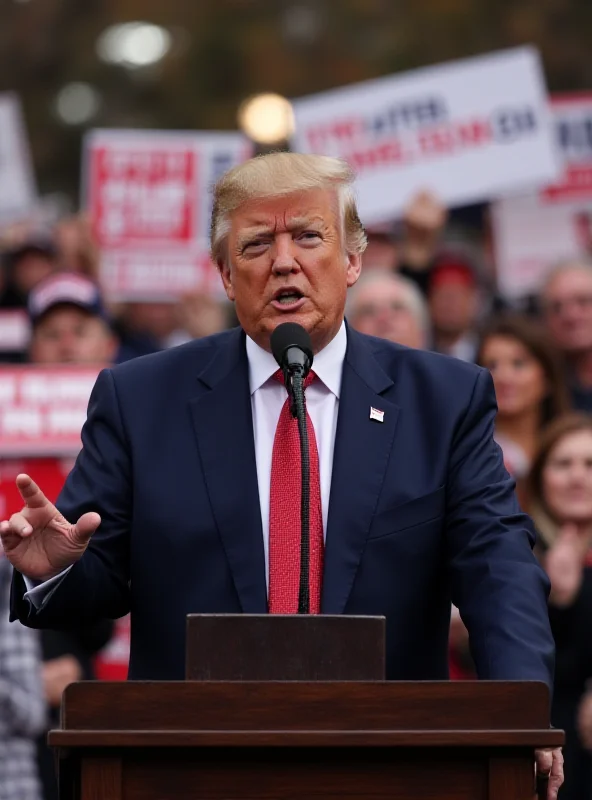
[447,370,554,687]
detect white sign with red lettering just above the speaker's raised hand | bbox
[0,366,100,457]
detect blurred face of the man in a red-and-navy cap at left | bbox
[30,306,116,364]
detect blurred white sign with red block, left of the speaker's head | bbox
[84,130,252,301]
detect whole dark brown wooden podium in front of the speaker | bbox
[49,616,563,800]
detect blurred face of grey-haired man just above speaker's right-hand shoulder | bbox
[349,280,426,348]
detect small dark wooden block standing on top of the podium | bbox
[185,614,386,681]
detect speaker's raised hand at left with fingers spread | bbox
[0,475,101,580]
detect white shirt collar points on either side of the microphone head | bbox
[247,322,347,399]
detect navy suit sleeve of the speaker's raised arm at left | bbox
[11,370,132,629]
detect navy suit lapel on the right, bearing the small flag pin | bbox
[321,327,399,614]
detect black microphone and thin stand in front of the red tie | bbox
[270,322,313,614]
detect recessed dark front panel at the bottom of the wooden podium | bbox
[124,750,488,800]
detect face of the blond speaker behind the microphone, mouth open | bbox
[219,189,361,352]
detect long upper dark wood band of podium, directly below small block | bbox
[62,681,549,731]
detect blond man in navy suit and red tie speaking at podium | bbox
[0,153,561,797]
